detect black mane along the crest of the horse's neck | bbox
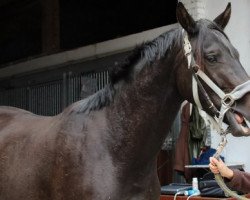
[67,29,182,114]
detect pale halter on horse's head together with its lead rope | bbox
[182,30,250,200]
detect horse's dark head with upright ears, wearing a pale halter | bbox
[177,3,250,136]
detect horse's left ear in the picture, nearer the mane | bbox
[176,2,196,34]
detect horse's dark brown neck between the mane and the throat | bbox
[108,44,182,170]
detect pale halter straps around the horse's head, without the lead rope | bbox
[182,30,250,134]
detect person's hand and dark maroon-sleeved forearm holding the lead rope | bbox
[209,157,250,193]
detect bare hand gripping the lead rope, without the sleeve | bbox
[209,157,233,179]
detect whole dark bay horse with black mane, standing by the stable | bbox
[0,3,250,200]
